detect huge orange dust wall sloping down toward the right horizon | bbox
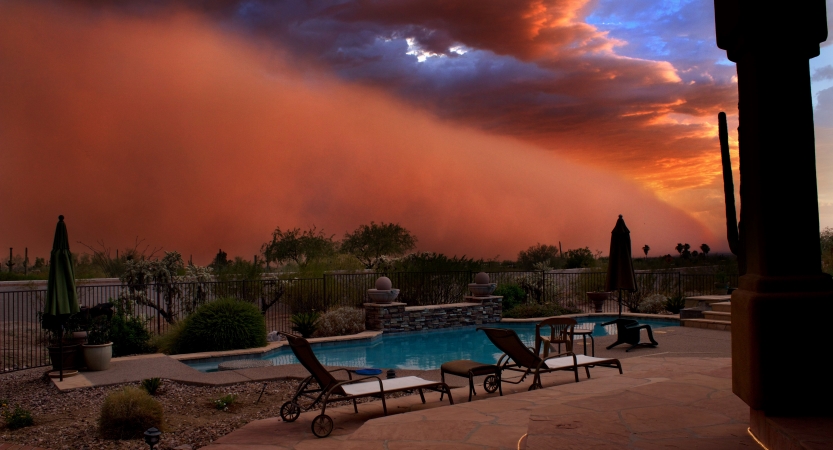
[0,2,721,263]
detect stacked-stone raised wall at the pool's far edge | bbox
[364,296,503,333]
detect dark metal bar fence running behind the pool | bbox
[0,271,738,373]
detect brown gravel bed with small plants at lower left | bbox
[0,368,404,450]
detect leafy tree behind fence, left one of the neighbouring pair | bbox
[260,225,336,267]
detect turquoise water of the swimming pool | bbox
[186,316,679,372]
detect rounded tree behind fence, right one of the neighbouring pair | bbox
[341,222,417,269]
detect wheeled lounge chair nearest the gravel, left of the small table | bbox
[280,333,454,438]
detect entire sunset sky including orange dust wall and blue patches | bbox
[0,0,833,264]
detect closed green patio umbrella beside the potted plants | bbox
[43,216,80,381]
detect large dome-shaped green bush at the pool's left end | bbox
[176,298,266,353]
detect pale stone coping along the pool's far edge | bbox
[176,313,680,370]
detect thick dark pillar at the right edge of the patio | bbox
[715,0,833,418]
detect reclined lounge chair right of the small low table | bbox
[478,327,622,391]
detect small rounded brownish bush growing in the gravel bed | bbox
[98,386,164,439]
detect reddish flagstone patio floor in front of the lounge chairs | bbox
[203,353,758,450]
